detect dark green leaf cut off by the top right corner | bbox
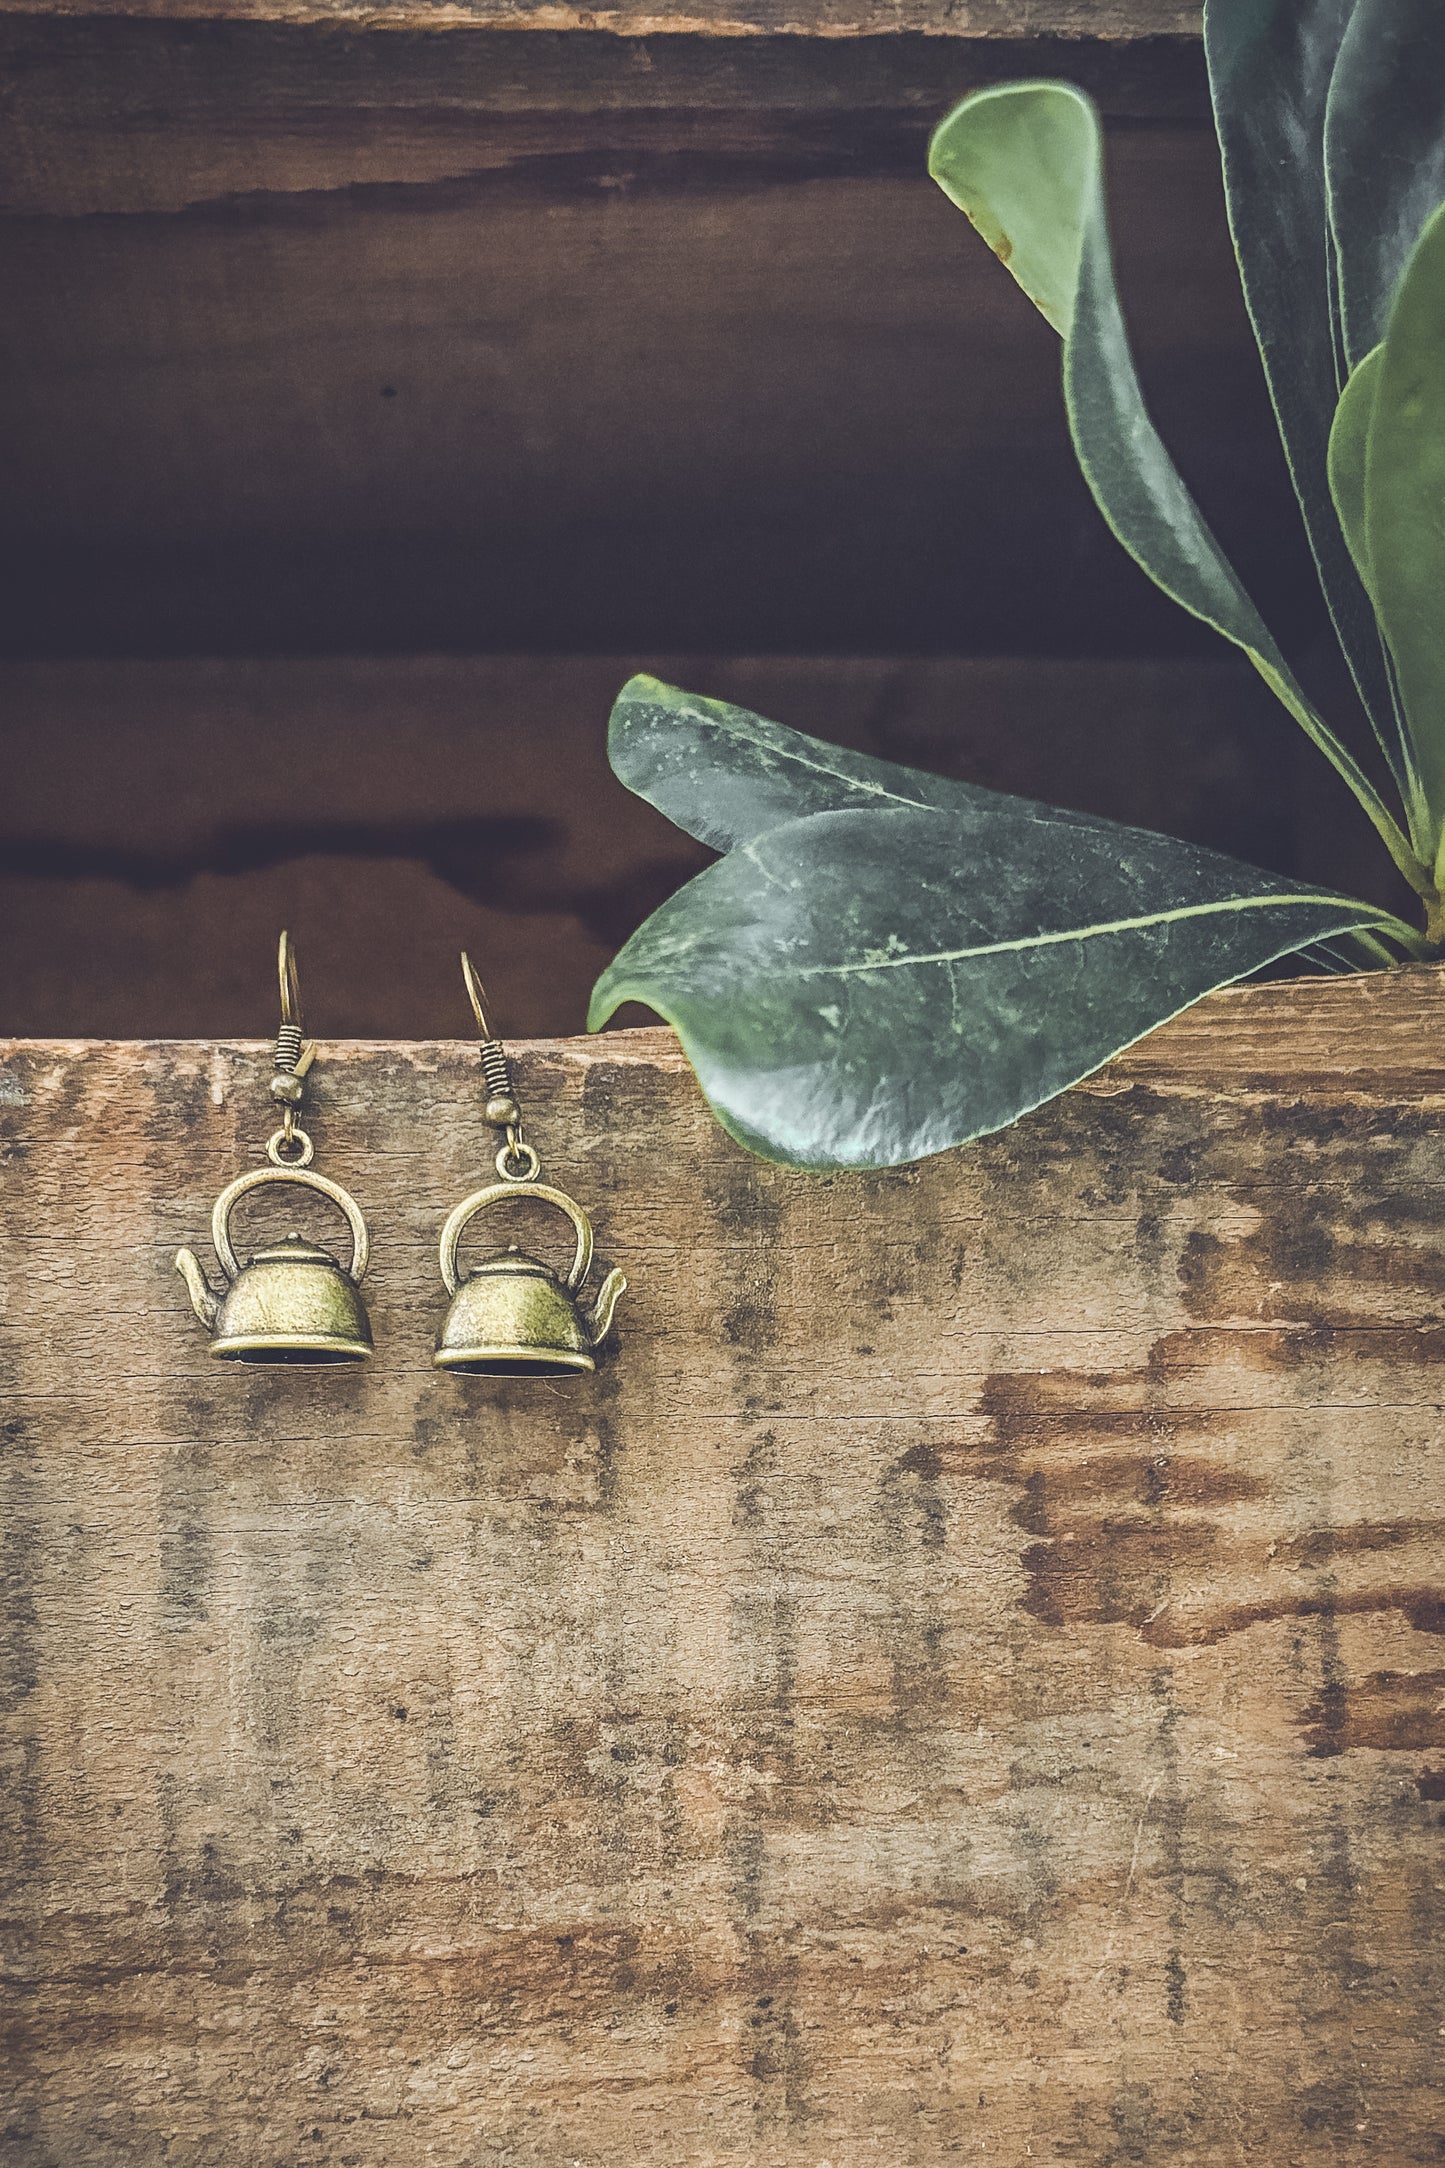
[1324,0,1445,369]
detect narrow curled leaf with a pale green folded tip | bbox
[929,82,1419,885]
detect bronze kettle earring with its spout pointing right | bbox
[433,952,626,1377]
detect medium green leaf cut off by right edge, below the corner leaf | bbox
[1365,206,1445,843]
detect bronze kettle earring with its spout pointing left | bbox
[175,934,370,1364]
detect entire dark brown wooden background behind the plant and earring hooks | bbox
[0,0,1393,1036]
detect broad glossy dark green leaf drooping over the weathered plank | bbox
[587,696,1415,1169]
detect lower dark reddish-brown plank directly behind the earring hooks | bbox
[0,650,1402,1038]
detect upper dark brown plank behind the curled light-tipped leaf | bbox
[0,17,1273,655]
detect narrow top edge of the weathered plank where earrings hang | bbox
[0,965,1445,1099]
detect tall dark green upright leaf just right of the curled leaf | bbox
[1205,0,1417,804]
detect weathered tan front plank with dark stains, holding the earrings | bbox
[0,971,1445,2168]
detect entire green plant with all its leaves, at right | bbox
[589,0,1445,1166]
